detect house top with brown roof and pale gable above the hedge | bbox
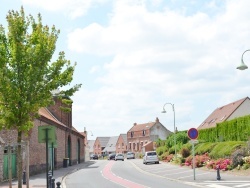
[197,97,250,130]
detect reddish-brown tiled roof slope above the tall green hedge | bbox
[197,97,249,129]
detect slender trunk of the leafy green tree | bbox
[17,131,23,188]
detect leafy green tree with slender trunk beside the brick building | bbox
[0,7,81,188]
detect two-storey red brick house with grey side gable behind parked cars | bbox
[127,118,171,153]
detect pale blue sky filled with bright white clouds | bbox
[0,0,250,140]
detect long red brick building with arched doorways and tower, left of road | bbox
[0,98,85,181]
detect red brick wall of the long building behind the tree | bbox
[0,120,85,181]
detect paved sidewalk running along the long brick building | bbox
[0,161,93,188]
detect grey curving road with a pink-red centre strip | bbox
[64,159,250,188]
